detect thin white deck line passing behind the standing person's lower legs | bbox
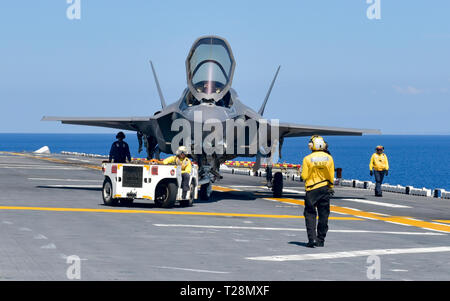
[153,224,444,236]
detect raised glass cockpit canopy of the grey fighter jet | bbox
[186,36,235,103]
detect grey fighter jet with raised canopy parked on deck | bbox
[42,36,379,199]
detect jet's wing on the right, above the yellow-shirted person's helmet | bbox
[279,123,381,137]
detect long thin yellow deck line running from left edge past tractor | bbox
[0,206,361,220]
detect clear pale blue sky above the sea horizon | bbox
[0,0,450,134]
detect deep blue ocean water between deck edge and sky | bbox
[0,134,450,190]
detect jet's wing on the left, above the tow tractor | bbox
[42,116,152,131]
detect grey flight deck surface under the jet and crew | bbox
[0,153,450,280]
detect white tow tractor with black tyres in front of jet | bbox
[102,161,198,208]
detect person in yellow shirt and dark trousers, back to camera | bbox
[301,136,334,248]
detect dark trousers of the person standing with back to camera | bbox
[303,186,330,242]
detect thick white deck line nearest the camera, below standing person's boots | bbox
[246,246,450,261]
